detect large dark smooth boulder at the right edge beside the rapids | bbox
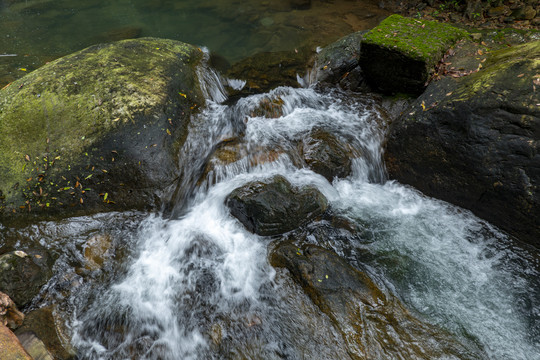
[385,41,540,247]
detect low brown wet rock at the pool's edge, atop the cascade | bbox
[227,49,312,95]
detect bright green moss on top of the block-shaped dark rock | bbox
[364,15,467,63]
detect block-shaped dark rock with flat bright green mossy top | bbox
[360,15,467,94]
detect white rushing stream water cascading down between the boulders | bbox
[0,63,540,360]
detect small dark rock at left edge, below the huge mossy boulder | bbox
[0,250,52,308]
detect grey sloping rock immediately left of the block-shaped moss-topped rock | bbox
[310,31,367,91]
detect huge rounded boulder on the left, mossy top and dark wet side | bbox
[0,38,204,220]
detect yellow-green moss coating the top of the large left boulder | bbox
[0,38,204,212]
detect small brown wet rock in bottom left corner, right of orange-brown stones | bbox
[15,306,75,360]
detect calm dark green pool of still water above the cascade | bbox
[0,0,388,86]
